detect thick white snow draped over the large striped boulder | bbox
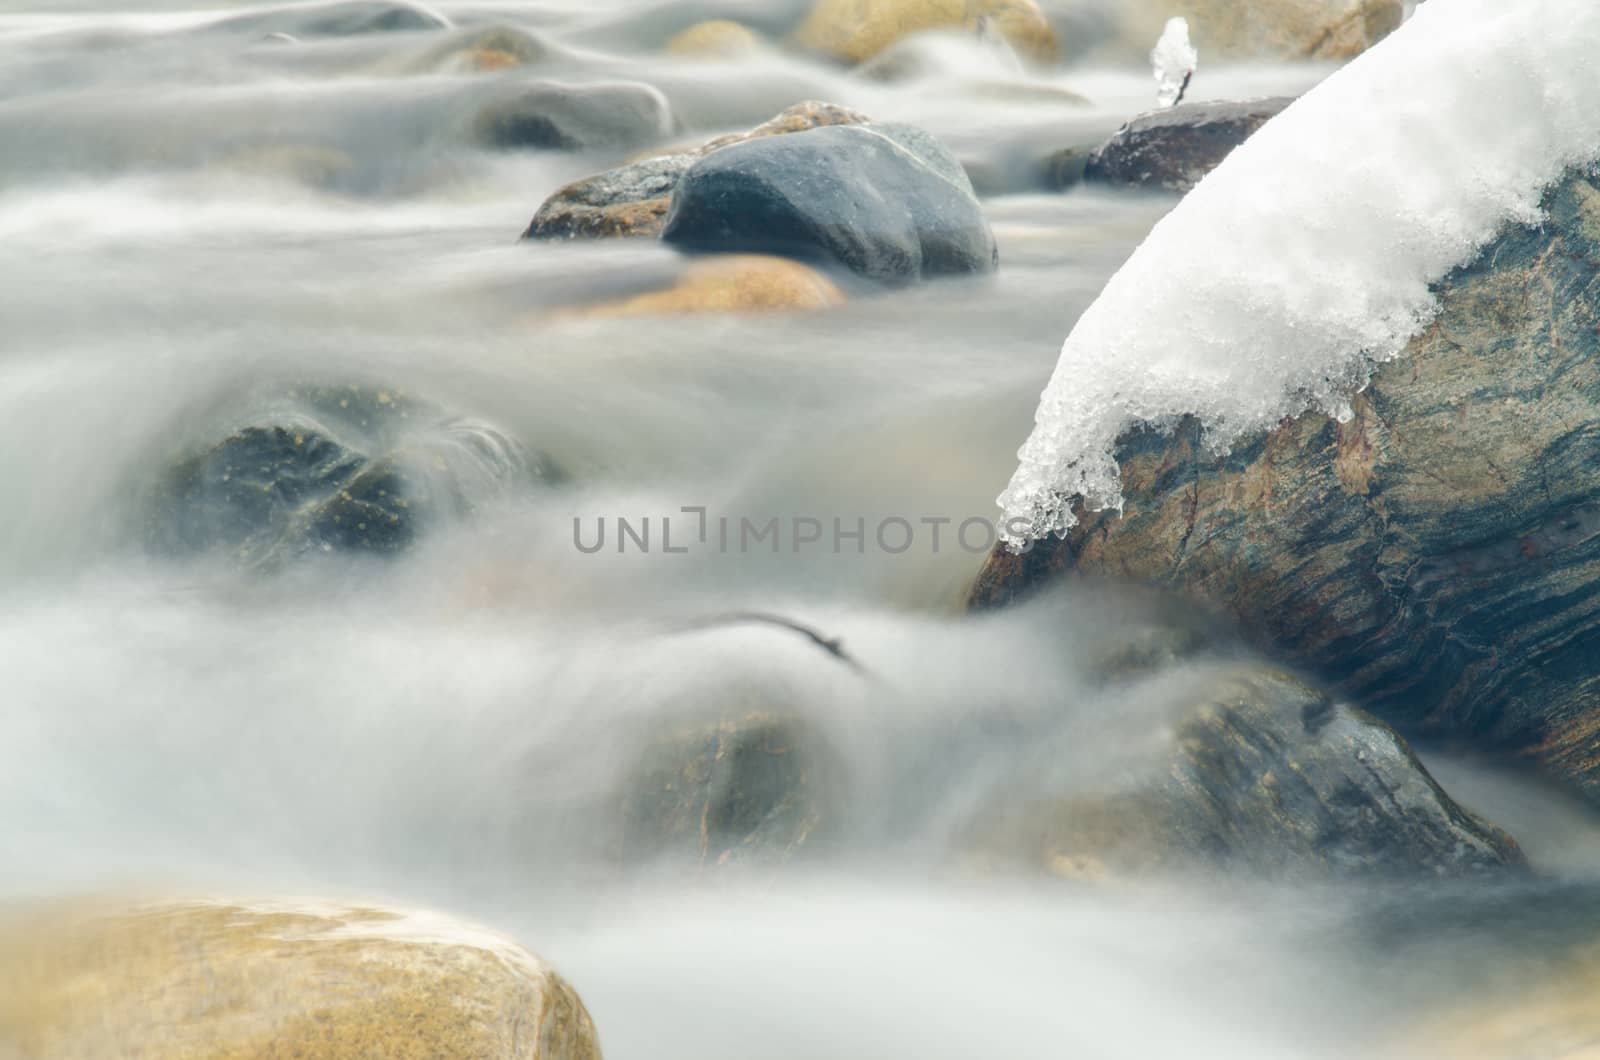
[998,0,1600,546]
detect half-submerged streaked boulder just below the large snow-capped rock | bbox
[960,663,1523,877]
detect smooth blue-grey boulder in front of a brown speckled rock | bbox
[661,123,998,283]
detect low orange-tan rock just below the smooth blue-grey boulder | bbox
[581,255,845,317]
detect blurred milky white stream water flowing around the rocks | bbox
[0,0,1600,1060]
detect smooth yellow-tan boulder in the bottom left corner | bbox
[0,901,600,1060]
